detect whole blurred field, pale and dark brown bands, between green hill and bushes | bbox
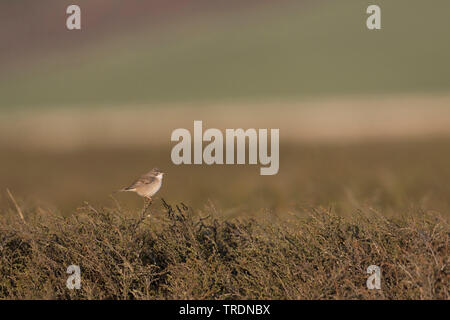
[0,96,450,215]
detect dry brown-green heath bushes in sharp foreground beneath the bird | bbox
[0,202,450,299]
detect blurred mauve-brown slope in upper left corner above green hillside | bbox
[0,0,267,67]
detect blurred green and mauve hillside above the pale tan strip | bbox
[0,0,450,109]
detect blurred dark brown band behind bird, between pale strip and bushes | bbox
[0,138,450,216]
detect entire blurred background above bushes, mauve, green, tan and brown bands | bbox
[0,0,450,216]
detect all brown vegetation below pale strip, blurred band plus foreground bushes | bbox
[0,139,450,299]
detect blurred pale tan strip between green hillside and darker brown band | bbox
[0,94,450,153]
